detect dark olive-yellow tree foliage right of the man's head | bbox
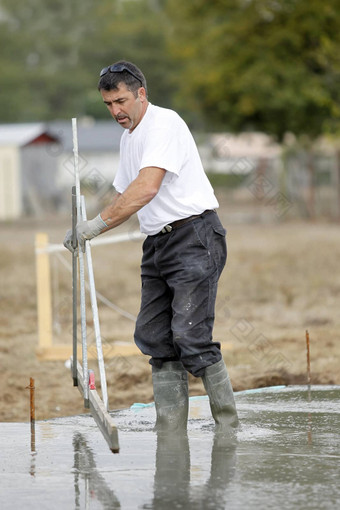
[168,0,340,139]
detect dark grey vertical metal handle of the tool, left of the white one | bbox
[72,186,78,386]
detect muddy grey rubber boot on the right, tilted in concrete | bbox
[202,359,238,432]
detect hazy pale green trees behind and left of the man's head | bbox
[0,0,172,122]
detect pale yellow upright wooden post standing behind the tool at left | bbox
[35,232,52,349]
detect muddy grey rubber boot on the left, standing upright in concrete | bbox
[152,361,189,432]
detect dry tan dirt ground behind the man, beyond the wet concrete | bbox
[0,191,340,422]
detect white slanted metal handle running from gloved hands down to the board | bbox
[81,196,109,409]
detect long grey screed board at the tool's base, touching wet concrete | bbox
[71,358,119,453]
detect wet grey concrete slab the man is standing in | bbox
[0,386,340,510]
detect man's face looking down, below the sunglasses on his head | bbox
[100,83,148,133]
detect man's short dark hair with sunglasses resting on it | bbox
[98,60,148,95]
